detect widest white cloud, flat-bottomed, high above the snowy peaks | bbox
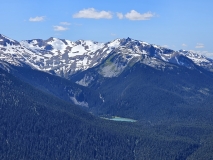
[73,8,112,19]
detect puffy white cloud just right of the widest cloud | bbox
[125,10,155,20]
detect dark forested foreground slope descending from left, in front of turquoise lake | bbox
[0,70,206,160]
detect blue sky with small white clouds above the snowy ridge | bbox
[0,0,213,58]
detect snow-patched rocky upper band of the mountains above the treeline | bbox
[0,35,213,78]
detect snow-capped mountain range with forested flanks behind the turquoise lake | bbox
[0,35,213,118]
